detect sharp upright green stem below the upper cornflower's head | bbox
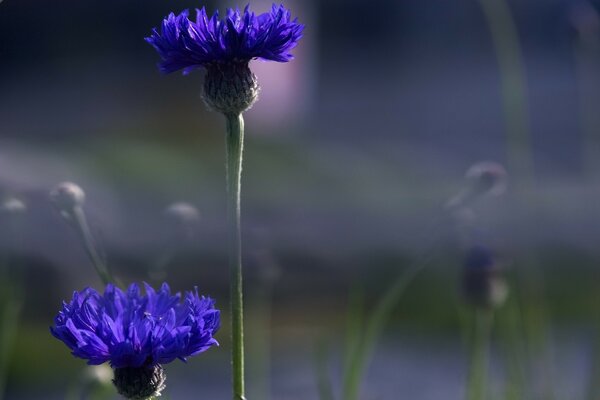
[225,114,245,400]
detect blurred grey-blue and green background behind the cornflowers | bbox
[0,0,600,400]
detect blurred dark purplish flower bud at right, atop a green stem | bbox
[462,246,508,308]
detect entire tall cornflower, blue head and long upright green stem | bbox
[146,4,304,400]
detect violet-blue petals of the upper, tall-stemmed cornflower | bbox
[146,4,304,73]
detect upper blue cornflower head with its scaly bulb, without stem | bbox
[146,4,304,115]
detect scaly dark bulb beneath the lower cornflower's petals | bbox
[113,364,166,400]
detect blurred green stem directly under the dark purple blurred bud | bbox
[467,308,493,400]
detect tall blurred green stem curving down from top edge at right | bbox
[480,0,554,399]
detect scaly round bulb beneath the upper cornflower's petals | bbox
[203,62,260,115]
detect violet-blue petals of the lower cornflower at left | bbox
[50,283,220,368]
